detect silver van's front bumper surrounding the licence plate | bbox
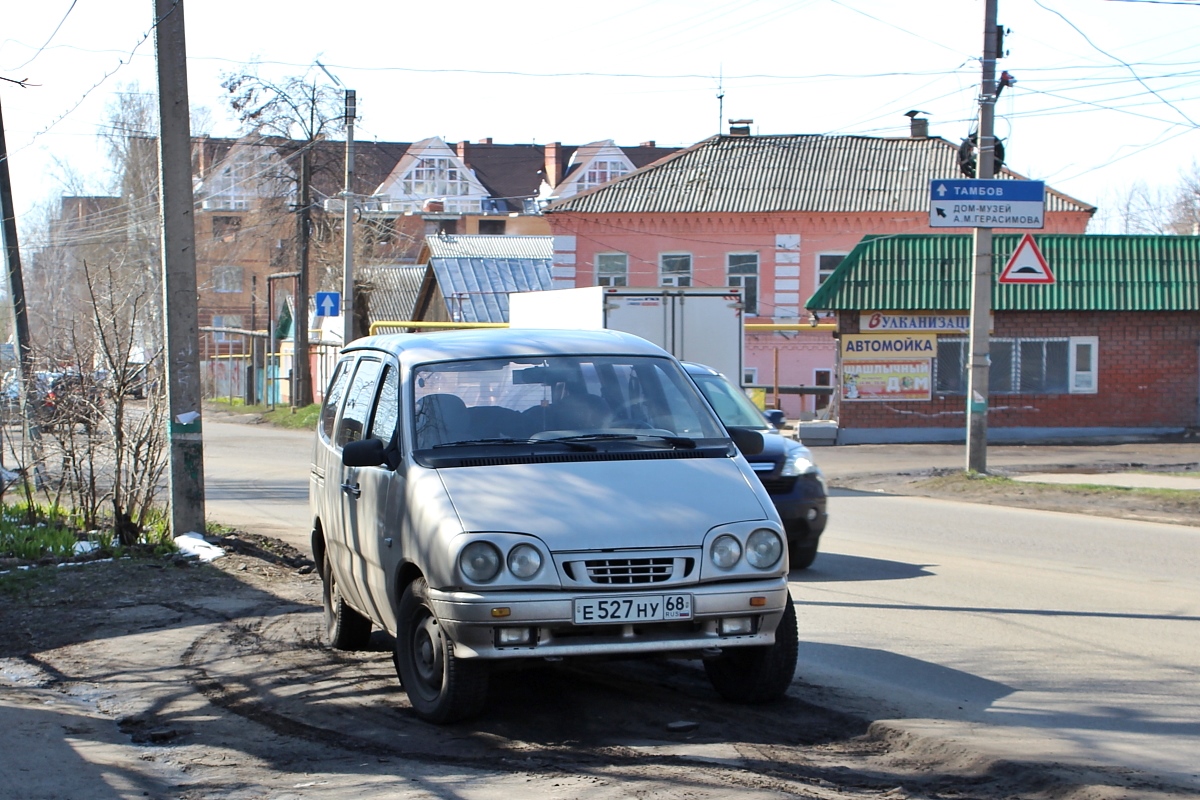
[428,577,792,658]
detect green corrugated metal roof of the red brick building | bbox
[805,234,1200,311]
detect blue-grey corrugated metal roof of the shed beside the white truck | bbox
[430,256,557,323]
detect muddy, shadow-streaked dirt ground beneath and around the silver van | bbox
[0,525,1189,800]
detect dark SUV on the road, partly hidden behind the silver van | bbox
[683,362,829,570]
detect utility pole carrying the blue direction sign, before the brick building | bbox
[967,0,1000,474]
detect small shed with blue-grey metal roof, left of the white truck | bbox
[413,235,559,323]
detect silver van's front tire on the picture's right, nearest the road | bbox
[704,597,799,704]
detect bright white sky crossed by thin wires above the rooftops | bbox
[0,0,1200,230]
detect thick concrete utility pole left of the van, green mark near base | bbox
[154,0,204,536]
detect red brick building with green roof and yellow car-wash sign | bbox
[808,234,1200,444]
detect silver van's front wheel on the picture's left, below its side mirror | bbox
[395,578,488,724]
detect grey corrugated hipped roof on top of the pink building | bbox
[546,136,1096,213]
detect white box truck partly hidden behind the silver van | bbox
[509,287,744,386]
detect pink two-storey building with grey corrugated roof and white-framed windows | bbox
[546,128,1096,416]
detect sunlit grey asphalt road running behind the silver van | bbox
[205,421,1200,790]
